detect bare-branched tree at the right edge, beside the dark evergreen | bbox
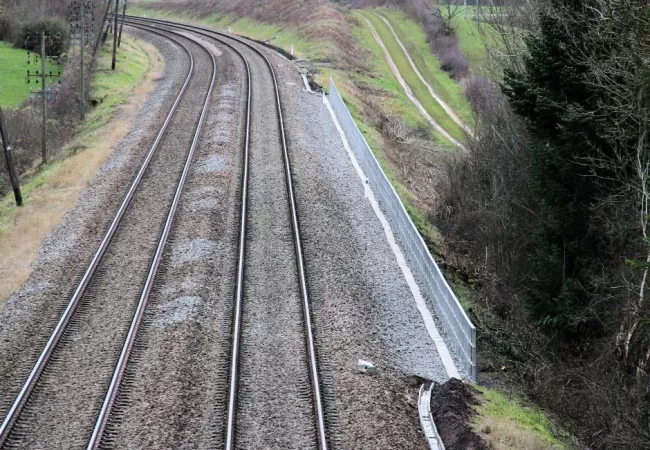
[565,0,650,382]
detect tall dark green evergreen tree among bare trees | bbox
[502,0,611,337]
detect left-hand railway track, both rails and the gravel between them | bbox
[0,23,216,448]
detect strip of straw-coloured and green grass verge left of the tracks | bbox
[0,35,162,300]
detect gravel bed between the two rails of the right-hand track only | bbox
[229,38,316,449]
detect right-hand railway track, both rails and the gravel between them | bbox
[129,17,328,450]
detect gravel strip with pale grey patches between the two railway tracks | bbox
[98,29,245,449]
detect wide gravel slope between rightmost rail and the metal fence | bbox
[274,41,447,449]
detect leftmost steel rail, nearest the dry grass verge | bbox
[0,29,194,448]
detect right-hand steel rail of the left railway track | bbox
[86,24,217,450]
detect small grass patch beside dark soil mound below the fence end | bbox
[472,386,567,450]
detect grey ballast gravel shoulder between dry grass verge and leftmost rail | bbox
[0,29,187,424]
